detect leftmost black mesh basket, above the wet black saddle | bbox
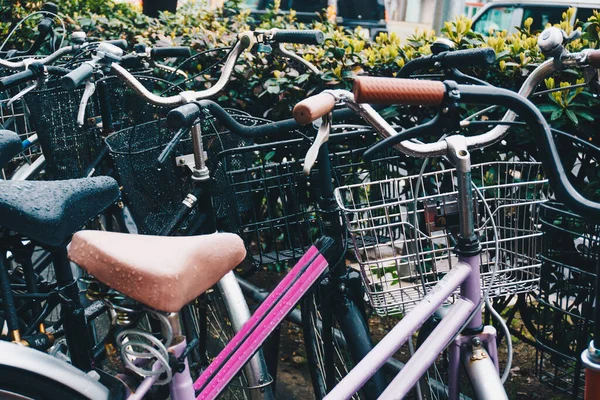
[25,77,169,179]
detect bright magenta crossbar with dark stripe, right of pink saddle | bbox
[194,246,328,400]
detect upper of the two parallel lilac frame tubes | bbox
[325,261,473,400]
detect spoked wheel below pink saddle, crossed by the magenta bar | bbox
[182,288,271,399]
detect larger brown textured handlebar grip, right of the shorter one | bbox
[353,76,446,106]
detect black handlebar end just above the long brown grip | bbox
[397,48,496,78]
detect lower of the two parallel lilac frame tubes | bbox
[379,297,475,400]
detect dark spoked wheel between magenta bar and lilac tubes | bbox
[301,284,384,399]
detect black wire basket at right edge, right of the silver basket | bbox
[536,202,600,399]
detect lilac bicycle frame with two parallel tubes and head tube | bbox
[325,256,497,400]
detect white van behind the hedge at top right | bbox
[473,0,600,35]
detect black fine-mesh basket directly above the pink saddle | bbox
[106,114,255,234]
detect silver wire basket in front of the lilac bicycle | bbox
[335,162,548,315]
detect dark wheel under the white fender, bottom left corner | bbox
[0,366,89,400]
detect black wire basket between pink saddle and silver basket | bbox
[215,126,406,268]
